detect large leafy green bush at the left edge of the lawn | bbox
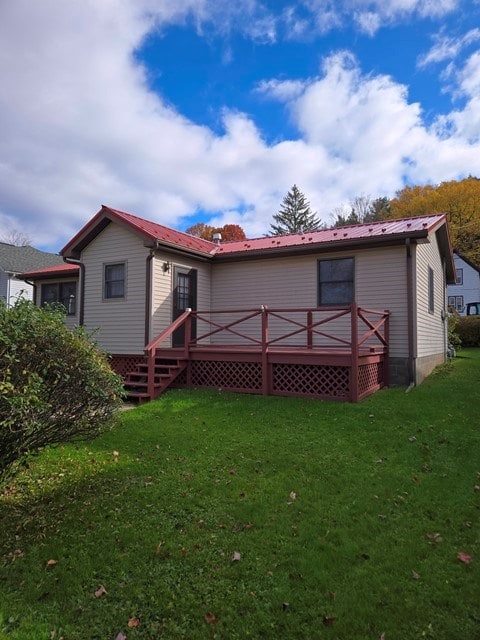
[0,300,123,480]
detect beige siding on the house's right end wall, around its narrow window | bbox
[415,234,446,358]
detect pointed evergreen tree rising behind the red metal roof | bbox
[270,184,323,236]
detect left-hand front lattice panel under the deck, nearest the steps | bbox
[191,360,262,393]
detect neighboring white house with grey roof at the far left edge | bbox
[0,242,63,306]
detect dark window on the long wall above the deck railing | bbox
[318,258,355,306]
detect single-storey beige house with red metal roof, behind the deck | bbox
[20,206,456,396]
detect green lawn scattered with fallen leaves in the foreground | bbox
[0,350,480,640]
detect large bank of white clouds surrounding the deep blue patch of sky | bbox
[0,0,480,250]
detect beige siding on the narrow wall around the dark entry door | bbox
[150,251,212,347]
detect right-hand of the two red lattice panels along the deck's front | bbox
[272,364,350,400]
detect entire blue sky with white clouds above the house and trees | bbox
[0,0,480,251]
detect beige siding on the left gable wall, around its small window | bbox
[81,222,149,354]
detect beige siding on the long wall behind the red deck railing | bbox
[212,246,408,357]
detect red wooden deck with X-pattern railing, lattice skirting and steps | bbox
[112,304,389,402]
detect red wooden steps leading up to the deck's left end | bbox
[124,355,187,402]
